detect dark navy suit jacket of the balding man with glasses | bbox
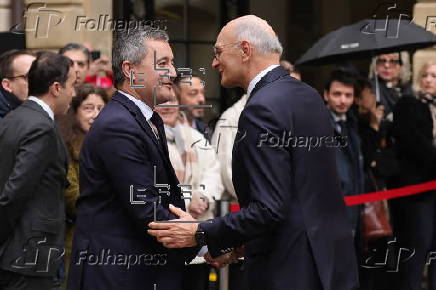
[201,67,358,290]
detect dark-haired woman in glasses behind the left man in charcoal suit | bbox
[60,84,108,286]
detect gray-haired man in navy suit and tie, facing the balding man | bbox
[68,28,195,290]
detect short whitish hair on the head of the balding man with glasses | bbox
[235,20,283,55]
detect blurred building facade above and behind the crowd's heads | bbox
[0,0,436,119]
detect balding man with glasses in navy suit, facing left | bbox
[149,15,358,290]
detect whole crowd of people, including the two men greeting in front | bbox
[0,16,436,290]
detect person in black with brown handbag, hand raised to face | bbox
[355,78,392,290]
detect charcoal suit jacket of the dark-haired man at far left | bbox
[0,100,68,276]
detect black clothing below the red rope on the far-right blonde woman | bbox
[390,191,436,290]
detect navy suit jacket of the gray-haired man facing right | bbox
[68,92,195,290]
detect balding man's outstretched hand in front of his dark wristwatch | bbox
[147,204,198,248]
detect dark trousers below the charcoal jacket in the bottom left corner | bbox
[0,270,60,290]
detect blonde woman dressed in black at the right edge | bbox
[390,61,436,290]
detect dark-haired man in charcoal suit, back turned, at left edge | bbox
[0,52,76,290]
